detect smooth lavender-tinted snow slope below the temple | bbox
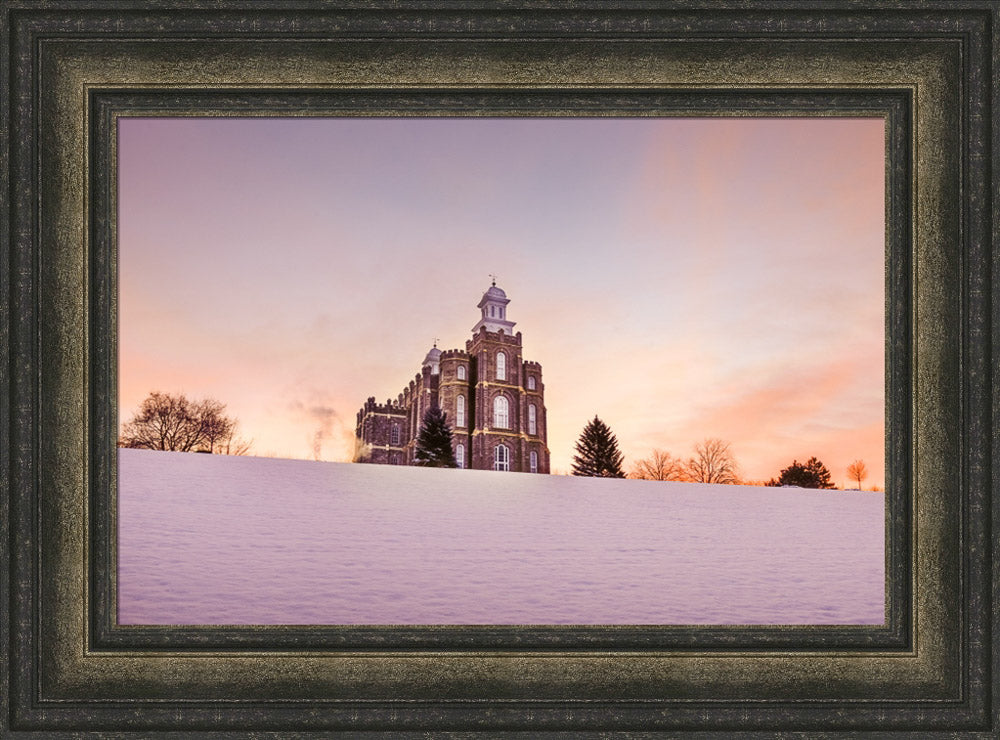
[118,450,885,624]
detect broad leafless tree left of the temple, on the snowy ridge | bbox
[118,391,251,455]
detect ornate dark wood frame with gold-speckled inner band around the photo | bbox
[0,0,1000,738]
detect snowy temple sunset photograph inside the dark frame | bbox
[113,114,886,627]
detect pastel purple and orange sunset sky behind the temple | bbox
[118,117,885,488]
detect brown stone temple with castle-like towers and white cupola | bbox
[355,281,549,473]
